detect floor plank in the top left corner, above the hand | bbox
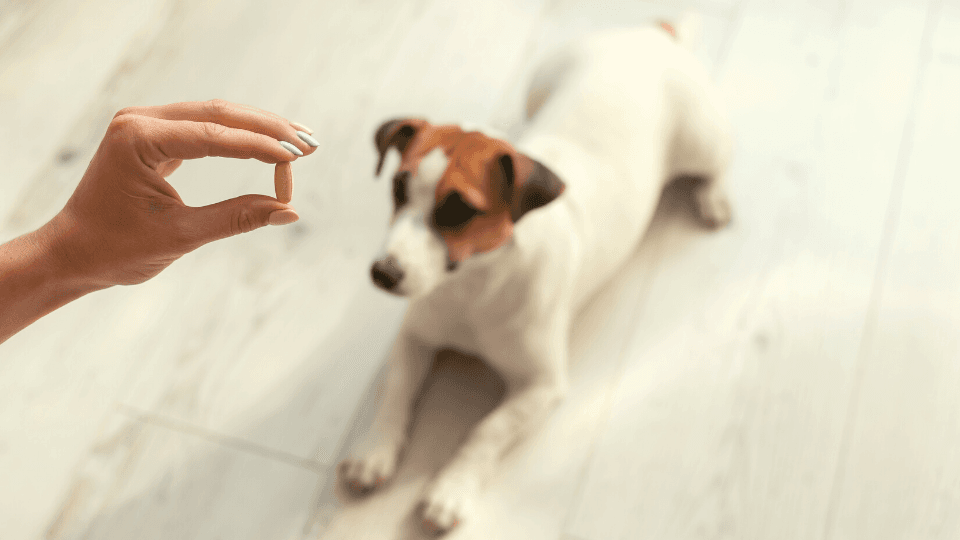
[0,0,169,228]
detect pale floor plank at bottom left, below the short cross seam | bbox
[44,412,323,540]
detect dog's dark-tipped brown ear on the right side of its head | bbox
[491,154,567,223]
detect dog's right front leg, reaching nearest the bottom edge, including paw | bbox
[422,335,567,533]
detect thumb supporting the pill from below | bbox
[181,195,300,245]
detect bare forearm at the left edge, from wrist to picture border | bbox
[0,217,104,344]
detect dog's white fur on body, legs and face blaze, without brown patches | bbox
[343,17,730,530]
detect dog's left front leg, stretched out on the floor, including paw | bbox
[340,331,434,493]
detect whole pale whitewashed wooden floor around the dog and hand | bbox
[0,0,960,540]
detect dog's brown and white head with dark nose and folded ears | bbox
[371,118,565,297]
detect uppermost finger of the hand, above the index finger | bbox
[117,99,318,155]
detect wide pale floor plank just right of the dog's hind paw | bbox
[567,2,925,539]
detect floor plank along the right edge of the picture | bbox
[825,2,960,540]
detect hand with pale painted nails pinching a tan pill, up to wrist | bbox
[48,100,315,289]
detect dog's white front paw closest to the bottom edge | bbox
[420,475,479,535]
